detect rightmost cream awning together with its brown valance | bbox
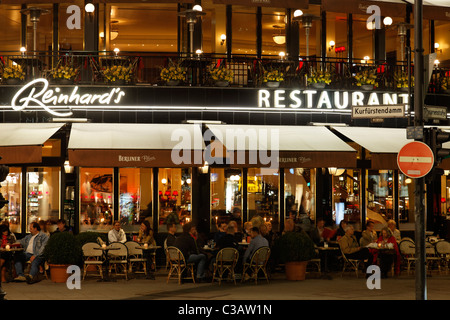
[333,127,413,170]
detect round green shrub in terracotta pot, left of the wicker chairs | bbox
[44,232,82,283]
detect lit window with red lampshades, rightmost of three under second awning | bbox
[158,168,192,232]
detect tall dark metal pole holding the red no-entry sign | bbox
[414,0,427,300]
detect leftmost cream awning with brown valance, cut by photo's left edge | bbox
[0,123,63,164]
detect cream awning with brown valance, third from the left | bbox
[205,125,356,168]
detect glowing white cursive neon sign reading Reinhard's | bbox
[11,78,125,117]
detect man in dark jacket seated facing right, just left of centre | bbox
[174,223,206,282]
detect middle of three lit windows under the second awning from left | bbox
[119,168,153,232]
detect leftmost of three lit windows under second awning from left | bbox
[80,168,114,232]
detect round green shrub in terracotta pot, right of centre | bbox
[274,232,316,280]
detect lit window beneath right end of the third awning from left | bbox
[332,169,361,230]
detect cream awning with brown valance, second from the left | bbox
[68,123,204,167]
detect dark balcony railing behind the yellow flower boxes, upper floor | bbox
[0,51,450,93]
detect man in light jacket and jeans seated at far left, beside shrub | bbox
[14,222,48,283]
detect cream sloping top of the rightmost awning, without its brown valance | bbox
[332,127,413,153]
